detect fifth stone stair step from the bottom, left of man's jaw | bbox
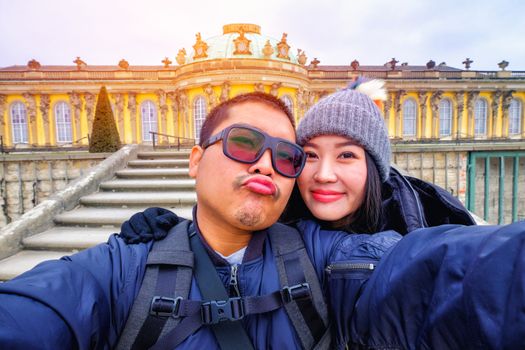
[100,179,195,192]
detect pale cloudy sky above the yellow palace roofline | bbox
[0,0,525,71]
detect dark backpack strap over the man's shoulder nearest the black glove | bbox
[117,220,193,349]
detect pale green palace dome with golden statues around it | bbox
[185,23,306,64]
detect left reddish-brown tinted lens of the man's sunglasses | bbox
[226,128,264,162]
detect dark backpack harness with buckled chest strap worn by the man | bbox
[117,220,331,350]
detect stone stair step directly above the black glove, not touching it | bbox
[80,191,197,208]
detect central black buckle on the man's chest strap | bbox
[201,297,244,325]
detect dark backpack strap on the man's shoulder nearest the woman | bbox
[268,223,331,349]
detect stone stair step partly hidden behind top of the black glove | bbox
[54,206,192,226]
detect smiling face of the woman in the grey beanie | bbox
[297,135,367,221]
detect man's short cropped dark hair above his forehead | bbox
[199,92,295,146]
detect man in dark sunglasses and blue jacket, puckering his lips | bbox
[0,93,399,349]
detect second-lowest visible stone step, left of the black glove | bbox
[22,226,115,251]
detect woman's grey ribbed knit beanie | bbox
[297,88,390,182]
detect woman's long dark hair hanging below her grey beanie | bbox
[279,151,382,234]
